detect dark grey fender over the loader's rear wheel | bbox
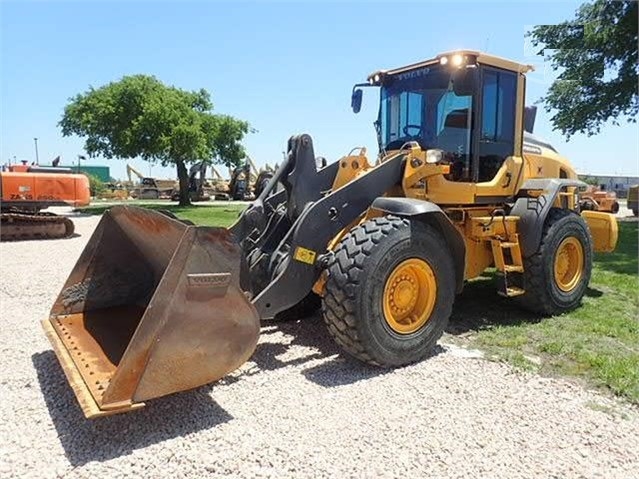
[510,178,587,258]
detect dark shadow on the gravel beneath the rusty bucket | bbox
[31,351,233,466]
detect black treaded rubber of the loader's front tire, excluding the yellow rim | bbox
[322,216,455,367]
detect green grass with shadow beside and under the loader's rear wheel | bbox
[449,222,639,404]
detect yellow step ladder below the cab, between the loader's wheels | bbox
[490,234,525,298]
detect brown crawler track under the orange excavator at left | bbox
[0,212,75,241]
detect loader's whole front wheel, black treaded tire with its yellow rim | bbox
[322,216,455,367]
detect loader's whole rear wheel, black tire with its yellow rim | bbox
[521,208,592,316]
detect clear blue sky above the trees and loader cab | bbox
[0,1,639,178]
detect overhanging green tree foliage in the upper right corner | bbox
[528,0,639,138]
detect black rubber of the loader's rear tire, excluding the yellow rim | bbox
[520,208,592,316]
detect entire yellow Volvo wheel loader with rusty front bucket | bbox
[43,50,617,418]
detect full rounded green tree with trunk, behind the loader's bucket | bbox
[59,75,249,205]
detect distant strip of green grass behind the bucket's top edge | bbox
[77,202,246,227]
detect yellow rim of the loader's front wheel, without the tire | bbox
[383,258,437,334]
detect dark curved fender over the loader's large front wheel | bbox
[371,197,466,294]
